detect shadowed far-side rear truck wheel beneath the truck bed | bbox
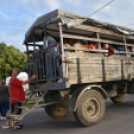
[45,104,69,118]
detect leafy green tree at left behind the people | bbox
[0,43,27,79]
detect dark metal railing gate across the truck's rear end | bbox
[27,44,62,83]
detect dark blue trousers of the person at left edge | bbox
[0,102,9,117]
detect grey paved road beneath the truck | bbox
[0,95,134,134]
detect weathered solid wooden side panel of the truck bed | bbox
[67,58,134,84]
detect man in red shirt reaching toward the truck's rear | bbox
[9,70,36,128]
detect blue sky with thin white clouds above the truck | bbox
[0,0,134,51]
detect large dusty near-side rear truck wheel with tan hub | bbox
[74,89,105,127]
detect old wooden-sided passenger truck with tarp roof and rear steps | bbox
[3,10,134,129]
